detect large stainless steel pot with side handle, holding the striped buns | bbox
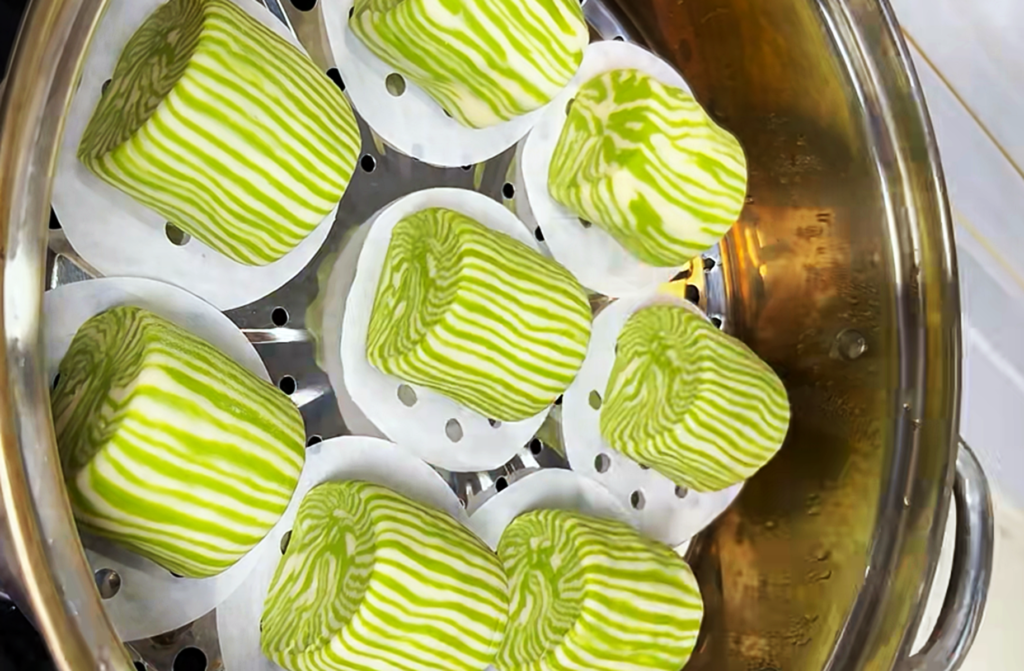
[0,0,992,671]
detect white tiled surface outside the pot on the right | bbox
[891,0,1024,671]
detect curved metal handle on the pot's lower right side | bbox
[897,438,994,671]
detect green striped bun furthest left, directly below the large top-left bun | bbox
[52,307,305,578]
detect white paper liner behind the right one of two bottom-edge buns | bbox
[469,468,635,551]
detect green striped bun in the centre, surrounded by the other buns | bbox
[367,208,591,422]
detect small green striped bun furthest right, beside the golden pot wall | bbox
[600,305,790,492]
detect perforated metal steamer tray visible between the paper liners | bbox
[41,0,729,671]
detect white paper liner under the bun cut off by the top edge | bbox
[321,0,544,168]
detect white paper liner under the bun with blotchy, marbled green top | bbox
[515,41,690,297]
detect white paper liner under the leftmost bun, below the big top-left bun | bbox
[43,278,270,640]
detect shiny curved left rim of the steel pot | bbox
[0,0,132,671]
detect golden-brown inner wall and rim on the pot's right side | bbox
[606,0,959,671]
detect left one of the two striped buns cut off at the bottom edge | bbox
[261,481,508,671]
